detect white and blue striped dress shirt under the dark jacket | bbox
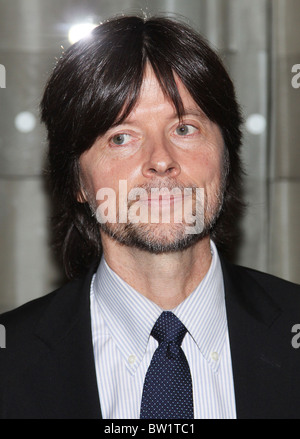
[91,241,236,419]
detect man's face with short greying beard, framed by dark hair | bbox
[79,67,226,253]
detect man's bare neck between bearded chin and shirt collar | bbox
[102,234,211,309]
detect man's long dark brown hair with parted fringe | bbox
[41,16,242,278]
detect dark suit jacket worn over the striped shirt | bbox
[0,260,300,419]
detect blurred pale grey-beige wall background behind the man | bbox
[0,0,300,311]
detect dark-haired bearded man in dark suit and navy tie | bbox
[0,13,300,419]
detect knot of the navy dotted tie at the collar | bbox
[151,311,187,346]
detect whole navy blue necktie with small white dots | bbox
[140,311,194,419]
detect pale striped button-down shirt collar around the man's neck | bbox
[93,241,227,373]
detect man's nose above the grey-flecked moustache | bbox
[142,141,181,178]
